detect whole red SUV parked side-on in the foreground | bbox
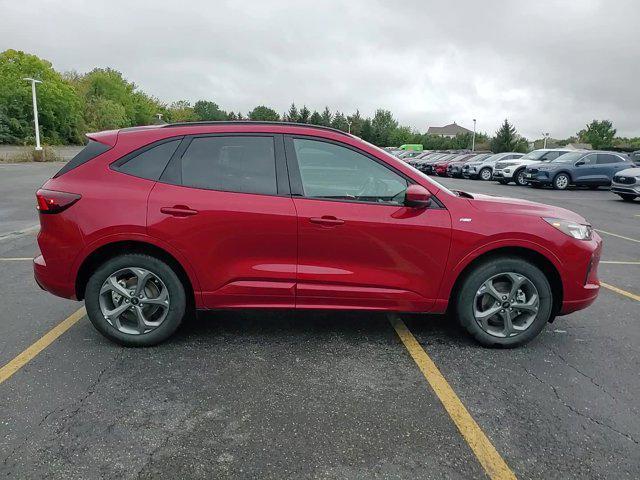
[34,122,602,346]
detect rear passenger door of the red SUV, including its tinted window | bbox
[147,134,297,308]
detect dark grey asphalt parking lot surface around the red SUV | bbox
[0,164,640,479]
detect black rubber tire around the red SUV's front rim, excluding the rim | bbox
[455,256,553,348]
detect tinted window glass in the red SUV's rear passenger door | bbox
[181,136,278,195]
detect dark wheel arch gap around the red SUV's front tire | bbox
[448,247,564,321]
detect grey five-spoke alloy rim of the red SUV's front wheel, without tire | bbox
[473,272,540,338]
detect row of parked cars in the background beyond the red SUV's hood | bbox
[392,148,640,201]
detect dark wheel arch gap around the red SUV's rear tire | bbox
[75,240,195,307]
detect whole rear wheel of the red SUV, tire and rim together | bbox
[85,254,187,347]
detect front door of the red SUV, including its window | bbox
[285,136,451,311]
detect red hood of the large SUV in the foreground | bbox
[469,193,589,223]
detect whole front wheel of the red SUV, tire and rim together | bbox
[455,257,553,347]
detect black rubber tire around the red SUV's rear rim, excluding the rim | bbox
[85,253,187,347]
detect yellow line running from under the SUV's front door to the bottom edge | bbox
[389,315,516,480]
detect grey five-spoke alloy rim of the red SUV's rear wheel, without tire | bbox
[99,267,170,335]
